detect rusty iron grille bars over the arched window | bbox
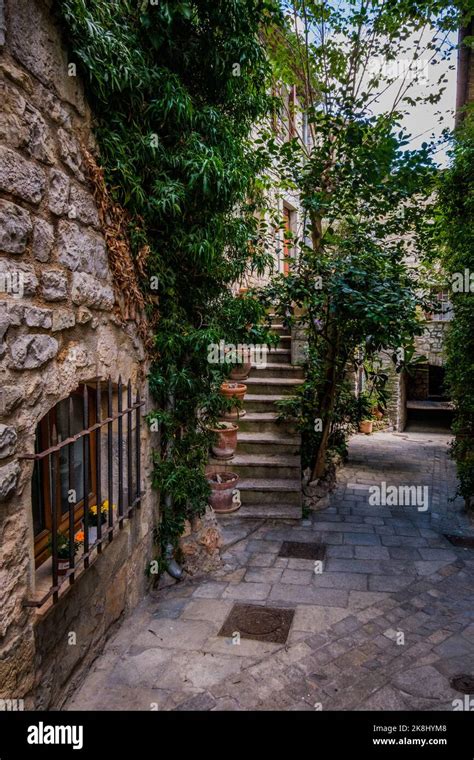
[21,377,144,607]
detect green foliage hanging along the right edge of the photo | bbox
[439,111,474,508]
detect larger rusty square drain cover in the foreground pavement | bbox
[218,604,295,644]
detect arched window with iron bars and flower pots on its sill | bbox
[23,378,143,607]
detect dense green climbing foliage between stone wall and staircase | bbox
[57,0,273,560]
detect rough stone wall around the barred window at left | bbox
[0,0,154,708]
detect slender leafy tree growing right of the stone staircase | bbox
[265,0,459,478]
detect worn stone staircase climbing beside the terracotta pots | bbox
[213,324,303,519]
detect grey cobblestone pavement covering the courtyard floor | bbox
[67,432,474,710]
